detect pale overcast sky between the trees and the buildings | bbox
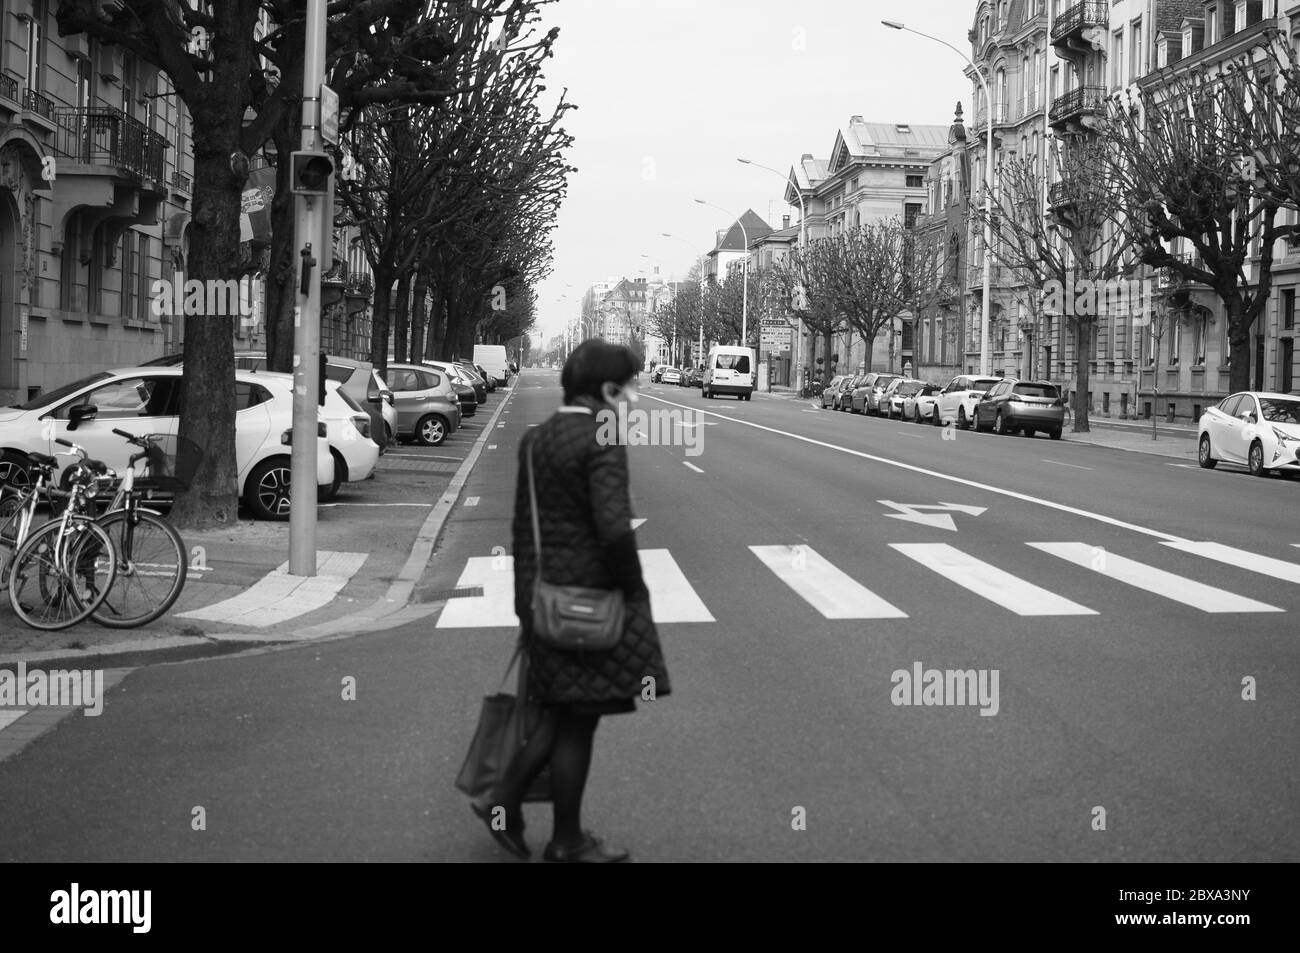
[527,0,976,343]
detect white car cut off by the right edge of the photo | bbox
[1196,391,1300,476]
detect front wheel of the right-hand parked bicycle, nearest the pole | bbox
[91,510,189,629]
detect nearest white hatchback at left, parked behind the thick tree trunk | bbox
[0,367,334,520]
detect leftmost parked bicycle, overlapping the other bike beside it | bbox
[7,438,117,632]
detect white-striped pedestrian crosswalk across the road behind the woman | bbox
[437,541,1300,629]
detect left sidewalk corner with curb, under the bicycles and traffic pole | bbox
[0,389,514,667]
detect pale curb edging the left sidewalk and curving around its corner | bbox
[0,386,516,668]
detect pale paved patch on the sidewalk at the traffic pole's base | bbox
[176,553,367,629]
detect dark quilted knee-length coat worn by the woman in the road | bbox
[512,400,670,711]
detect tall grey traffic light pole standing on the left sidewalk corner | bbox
[289,0,326,576]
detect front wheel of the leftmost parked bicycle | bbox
[9,516,117,632]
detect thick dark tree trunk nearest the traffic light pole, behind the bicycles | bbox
[170,140,244,529]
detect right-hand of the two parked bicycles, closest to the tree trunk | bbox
[76,428,203,629]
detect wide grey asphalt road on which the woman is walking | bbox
[0,371,1300,861]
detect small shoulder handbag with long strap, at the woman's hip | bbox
[528,436,625,651]
